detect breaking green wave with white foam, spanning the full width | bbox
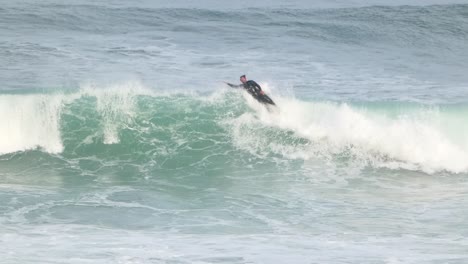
[0,83,468,173]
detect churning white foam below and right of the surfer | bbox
[231,98,468,173]
